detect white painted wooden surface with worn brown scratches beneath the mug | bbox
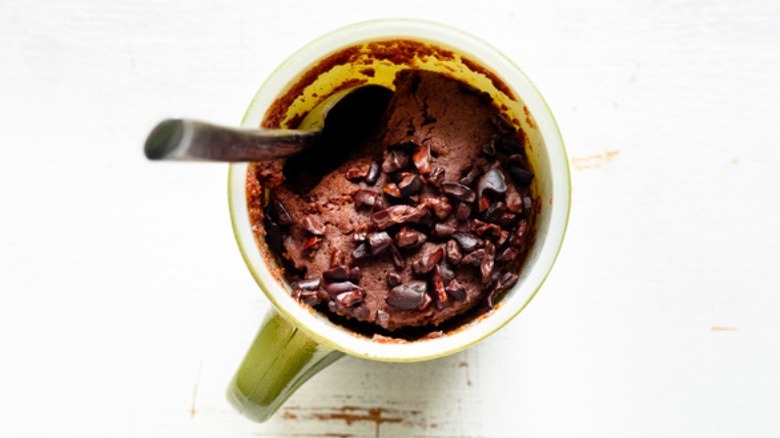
[0,0,780,437]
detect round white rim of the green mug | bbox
[228,19,571,362]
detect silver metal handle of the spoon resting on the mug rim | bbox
[144,119,321,162]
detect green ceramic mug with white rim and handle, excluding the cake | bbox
[222,20,571,421]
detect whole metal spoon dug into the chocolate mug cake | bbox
[144,85,393,162]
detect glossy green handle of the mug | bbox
[227,309,344,422]
